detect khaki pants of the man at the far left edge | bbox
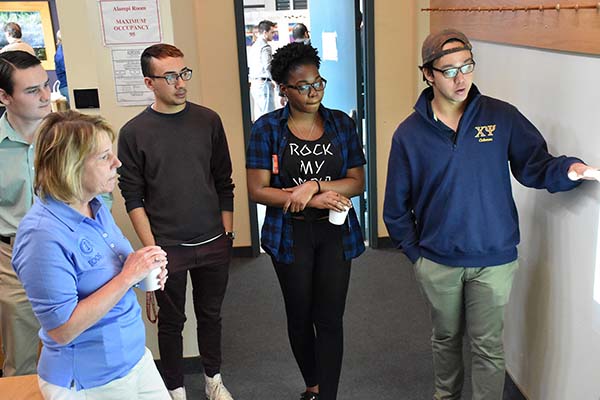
[0,242,40,376]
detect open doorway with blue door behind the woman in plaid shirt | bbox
[234,0,377,256]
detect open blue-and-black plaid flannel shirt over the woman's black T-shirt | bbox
[246,105,366,264]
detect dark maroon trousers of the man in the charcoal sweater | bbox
[155,235,231,390]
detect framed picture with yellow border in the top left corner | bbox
[0,1,56,70]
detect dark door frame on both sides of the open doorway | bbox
[233,0,378,257]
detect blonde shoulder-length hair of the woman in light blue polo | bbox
[34,111,115,203]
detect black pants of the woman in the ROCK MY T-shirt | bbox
[273,220,350,400]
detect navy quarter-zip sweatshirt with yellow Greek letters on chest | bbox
[383,85,581,267]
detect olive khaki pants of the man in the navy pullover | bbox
[415,257,518,400]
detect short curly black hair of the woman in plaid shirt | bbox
[270,43,321,83]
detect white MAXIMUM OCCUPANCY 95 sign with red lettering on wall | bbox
[98,0,162,46]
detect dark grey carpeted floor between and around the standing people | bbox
[171,249,523,400]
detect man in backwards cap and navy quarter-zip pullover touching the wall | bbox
[383,29,591,400]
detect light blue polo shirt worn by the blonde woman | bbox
[12,197,146,390]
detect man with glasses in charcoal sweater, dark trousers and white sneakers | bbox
[119,44,234,400]
